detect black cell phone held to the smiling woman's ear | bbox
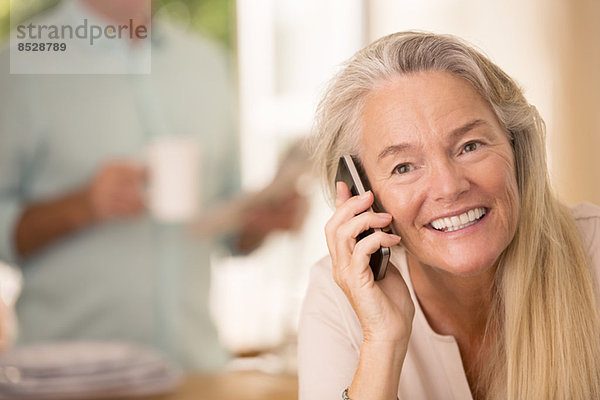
[335,155,390,281]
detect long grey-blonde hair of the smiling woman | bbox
[313,32,600,400]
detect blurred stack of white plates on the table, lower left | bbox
[0,342,181,400]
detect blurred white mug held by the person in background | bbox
[147,136,201,222]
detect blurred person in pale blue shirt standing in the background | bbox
[0,0,303,370]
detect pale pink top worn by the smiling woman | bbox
[298,204,600,400]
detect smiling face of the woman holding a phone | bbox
[360,71,518,275]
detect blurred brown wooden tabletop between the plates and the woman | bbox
[139,371,298,400]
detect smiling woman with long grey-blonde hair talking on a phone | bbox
[299,32,600,400]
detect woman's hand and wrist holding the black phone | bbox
[325,182,414,348]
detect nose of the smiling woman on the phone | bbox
[430,160,470,202]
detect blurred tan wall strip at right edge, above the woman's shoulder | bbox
[551,0,600,204]
